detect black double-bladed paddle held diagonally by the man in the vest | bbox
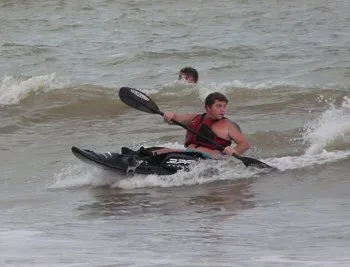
[119,87,275,169]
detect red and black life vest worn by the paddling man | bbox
[185,113,231,150]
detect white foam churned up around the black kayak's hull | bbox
[50,142,263,189]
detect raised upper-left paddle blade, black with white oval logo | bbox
[119,87,161,114]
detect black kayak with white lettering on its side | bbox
[72,146,208,176]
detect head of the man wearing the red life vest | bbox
[204,92,228,120]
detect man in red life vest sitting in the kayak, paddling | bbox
[154,92,250,156]
